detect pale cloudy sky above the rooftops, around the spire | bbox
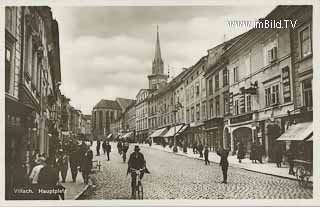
[52,6,274,114]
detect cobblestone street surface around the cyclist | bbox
[80,143,312,199]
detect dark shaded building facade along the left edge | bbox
[5,7,61,197]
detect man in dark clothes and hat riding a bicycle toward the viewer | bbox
[127,145,149,198]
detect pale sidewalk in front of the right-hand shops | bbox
[143,144,313,182]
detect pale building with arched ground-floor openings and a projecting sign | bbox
[223,6,312,161]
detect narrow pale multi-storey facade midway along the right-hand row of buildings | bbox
[183,56,209,146]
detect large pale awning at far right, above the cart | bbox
[277,122,313,141]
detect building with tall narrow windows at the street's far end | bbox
[91,99,122,139]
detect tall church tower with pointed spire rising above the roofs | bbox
[148,25,168,89]
